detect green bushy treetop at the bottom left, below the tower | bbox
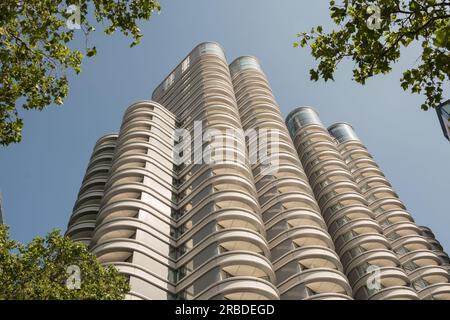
[0,225,129,300]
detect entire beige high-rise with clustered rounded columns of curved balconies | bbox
[66,42,449,300]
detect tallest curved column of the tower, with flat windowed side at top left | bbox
[153,42,279,299]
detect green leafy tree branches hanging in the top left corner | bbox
[0,0,160,145]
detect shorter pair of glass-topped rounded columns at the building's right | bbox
[287,107,450,300]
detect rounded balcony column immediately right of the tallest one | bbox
[230,56,351,299]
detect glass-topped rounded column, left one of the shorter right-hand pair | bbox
[287,107,417,300]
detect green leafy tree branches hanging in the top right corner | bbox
[294,0,450,110]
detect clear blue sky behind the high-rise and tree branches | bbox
[0,0,450,249]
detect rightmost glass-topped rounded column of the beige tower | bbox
[329,123,450,299]
